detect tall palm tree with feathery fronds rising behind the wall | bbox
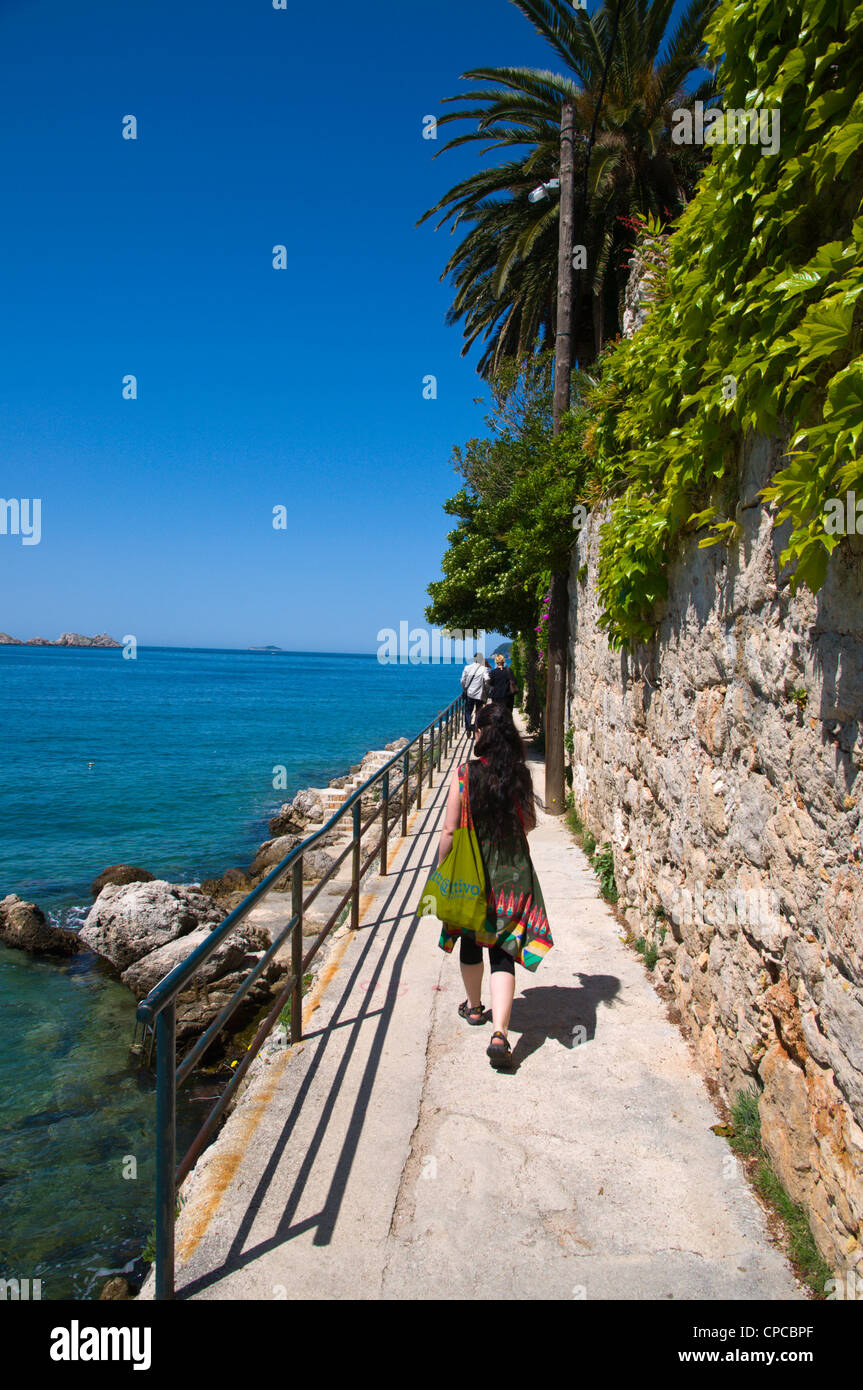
[420,0,718,378]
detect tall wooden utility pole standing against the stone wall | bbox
[545,101,575,816]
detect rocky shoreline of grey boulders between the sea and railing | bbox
[0,738,417,1061]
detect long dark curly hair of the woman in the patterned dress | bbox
[468,705,534,844]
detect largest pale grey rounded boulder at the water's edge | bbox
[81,878,225,970]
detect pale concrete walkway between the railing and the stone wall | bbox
[142,722,806,1300]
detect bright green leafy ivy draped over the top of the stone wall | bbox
[585,0,863,648]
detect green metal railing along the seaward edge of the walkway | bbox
[136,695,464,1300]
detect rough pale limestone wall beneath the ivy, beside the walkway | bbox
[567,438,863,1273]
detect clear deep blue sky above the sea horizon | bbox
[0,0,697,652]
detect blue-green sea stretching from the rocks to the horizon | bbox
[0,646,460,1300]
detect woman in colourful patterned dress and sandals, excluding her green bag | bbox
[438,705,554,1069]
